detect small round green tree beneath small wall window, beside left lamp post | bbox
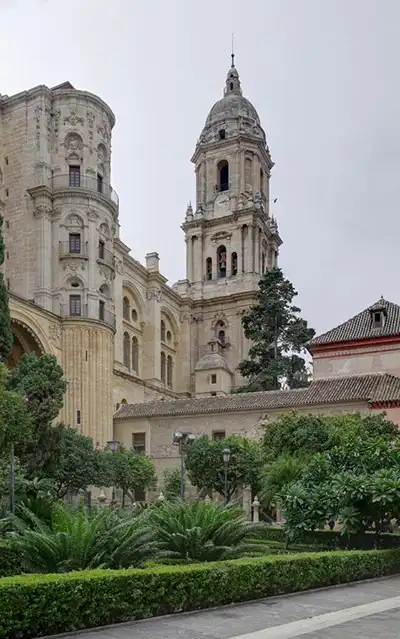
[112,446,157,507]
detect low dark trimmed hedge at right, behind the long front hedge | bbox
[252,526,400,550]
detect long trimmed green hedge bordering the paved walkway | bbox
[0,550,400,639]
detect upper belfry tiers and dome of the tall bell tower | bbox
[182,55,282,299]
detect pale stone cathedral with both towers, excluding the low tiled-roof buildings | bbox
[0,65,281,446]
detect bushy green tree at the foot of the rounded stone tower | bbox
[48,428,113,498]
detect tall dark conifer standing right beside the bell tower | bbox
[239,268,315,392]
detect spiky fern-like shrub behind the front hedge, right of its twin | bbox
[149,500,260,563]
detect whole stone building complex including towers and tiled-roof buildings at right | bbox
[0,57,400,496]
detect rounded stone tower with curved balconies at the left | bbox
[0,82,118,444]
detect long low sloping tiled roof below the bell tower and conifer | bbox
[115,373,400,419]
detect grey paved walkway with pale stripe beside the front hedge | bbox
[54,577,400,639]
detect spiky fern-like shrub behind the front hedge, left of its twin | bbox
[12,504,156,573]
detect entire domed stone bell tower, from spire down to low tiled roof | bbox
[179,56,282,396]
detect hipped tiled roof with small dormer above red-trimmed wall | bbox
[309,298,400,350]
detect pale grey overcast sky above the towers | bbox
[0,0,400,332]
